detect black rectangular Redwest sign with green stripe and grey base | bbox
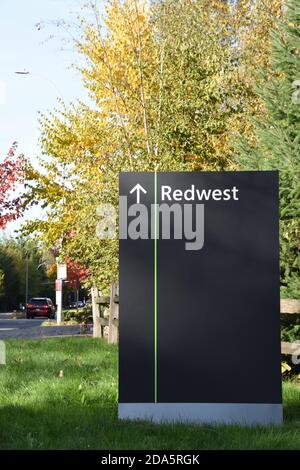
[119,172,282,423]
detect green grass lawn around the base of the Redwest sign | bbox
[0,337,300,450]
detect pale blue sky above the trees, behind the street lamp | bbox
[0,0,94,234]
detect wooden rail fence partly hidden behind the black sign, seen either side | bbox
[92,284,300,356]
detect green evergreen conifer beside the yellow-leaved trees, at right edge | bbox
[235,0,300,298]
